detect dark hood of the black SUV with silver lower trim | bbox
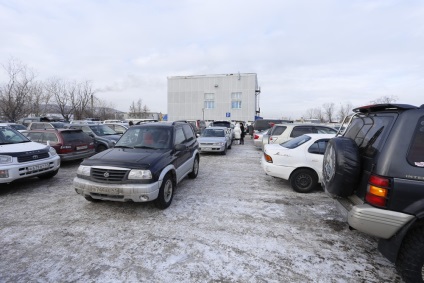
[81,148,170,169]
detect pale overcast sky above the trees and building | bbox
[0,0,424,119]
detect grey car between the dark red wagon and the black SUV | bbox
[69,124,121,152]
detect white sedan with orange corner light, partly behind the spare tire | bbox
[261,134,335,193]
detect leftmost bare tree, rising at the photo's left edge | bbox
[0,58,35,121]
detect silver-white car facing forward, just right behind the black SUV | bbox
[197,127,232,155]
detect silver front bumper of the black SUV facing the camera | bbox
[73,177,161,202]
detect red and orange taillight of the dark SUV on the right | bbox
[365,175,390,207]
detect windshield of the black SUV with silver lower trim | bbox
[115,127,172,149]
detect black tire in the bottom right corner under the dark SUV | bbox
[396,226,424,282]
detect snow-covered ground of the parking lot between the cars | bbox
[0,137,402,282]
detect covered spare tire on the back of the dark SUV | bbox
[322,137,360,197]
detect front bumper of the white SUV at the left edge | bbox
[0,155,60,183]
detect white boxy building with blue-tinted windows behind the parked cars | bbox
[168,73,260,121]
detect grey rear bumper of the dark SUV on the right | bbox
[336,197,414,239]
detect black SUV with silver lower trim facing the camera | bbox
[74,122,199,209]
